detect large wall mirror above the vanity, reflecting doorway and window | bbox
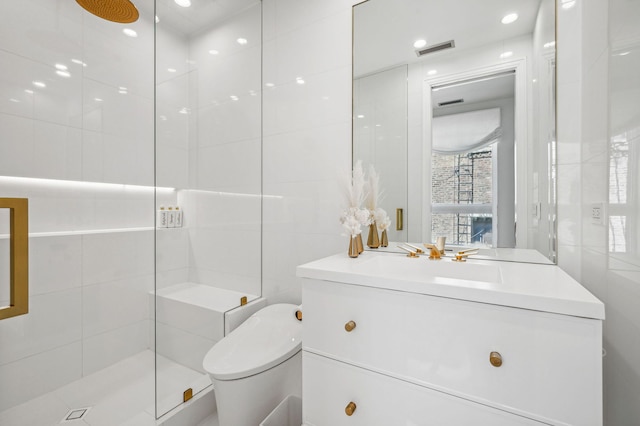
[353,0,556,263]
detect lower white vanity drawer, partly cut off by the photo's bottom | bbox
[302,352,542,426]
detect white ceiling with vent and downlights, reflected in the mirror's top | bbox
[354,0,540,76]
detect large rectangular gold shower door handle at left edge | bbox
[0,198,29,320]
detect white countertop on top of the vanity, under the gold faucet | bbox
[296,251,604,319]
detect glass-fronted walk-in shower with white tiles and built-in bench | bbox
[0,0,264,425]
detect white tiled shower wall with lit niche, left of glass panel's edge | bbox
[0,0,158,410]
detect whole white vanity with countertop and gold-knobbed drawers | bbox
[297,252,604,426]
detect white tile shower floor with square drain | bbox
[0,350,211,426]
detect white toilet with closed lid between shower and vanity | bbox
[202,303,302,426]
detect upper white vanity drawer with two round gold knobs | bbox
[302,279,602,426]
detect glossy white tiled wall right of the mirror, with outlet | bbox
[558,0,640,426]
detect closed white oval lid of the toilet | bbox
[202,304,302,380]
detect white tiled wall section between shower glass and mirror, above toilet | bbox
[262,0,353,303]
